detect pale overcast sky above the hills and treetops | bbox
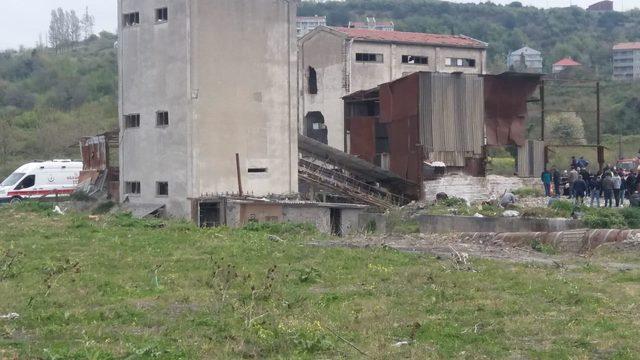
[0,0,640,49]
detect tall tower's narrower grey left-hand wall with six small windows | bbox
[118,0,190,216]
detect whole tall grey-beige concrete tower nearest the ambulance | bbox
[118,0,298,217]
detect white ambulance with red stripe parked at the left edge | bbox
[0,160,82,204]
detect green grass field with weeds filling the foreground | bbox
[0,205,640,359]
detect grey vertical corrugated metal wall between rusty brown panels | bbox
[419,73,484,167]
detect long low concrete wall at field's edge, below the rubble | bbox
[417,215,584,234]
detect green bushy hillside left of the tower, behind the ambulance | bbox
[0,32,118,176]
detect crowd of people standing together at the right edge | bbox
[541,157,640,207]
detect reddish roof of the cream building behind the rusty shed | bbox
[331,27,487,49]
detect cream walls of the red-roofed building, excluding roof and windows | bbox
[299,30,486,150]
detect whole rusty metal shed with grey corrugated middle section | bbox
[343,72,544,187]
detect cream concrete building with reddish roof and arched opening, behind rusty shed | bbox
[299,27,487,150]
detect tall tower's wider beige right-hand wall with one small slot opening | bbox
[190,0,298,195]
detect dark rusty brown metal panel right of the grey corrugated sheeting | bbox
[484,73,540,146]
